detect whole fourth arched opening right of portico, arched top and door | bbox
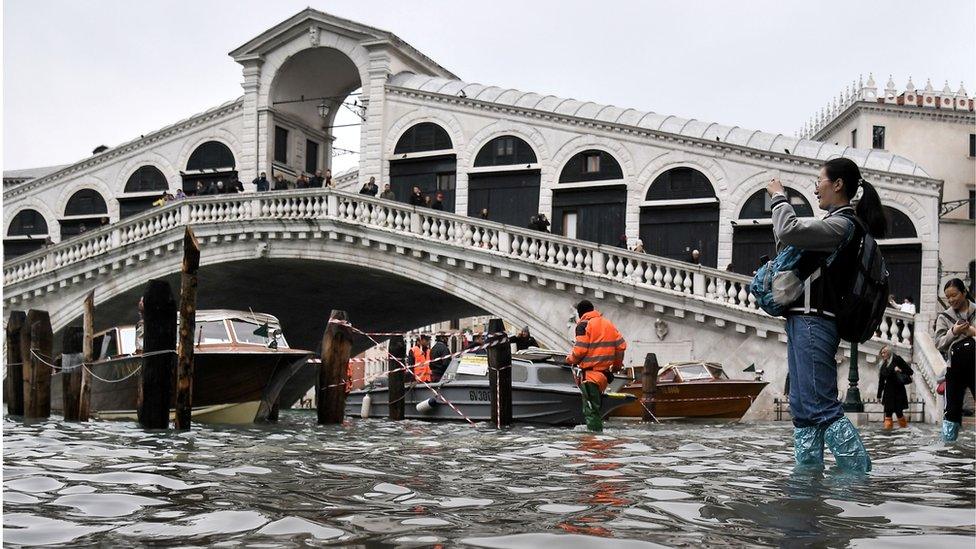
[640,167,719,267]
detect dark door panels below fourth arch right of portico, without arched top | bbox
[640,203,718,267]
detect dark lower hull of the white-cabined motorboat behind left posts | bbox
[51,350,310,423]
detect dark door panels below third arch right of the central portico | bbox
[551,185,627,246]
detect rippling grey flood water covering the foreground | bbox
[3,411,976,549]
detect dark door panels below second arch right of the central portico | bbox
[468,170,540,227]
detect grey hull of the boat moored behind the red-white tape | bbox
[346,381,632,425]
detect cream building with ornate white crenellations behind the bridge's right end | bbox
[802,75,976,303]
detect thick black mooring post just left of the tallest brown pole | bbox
[138,279,176,429]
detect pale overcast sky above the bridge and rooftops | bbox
[2,0,976,170]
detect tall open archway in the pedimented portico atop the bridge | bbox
[270,47,369,188]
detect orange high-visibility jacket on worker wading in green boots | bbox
[566,311,627,392]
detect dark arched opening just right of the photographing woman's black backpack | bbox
[878,206,922,307]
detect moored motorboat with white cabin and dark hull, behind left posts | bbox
[51,310,312,423]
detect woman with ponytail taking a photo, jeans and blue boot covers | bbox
[766,158,887,472]
